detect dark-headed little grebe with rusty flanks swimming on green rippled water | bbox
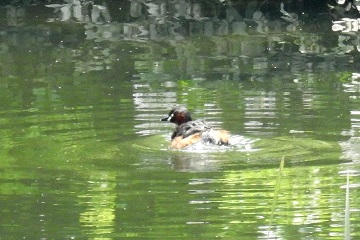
[161,106,230,149]
